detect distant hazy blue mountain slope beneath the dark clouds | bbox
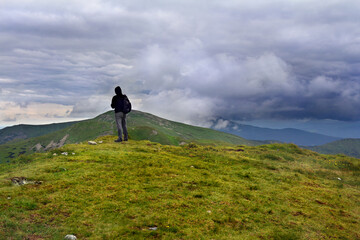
[213,120,339,146]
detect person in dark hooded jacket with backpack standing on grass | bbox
[111,86,131,142]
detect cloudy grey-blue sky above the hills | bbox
[0,0,360,137]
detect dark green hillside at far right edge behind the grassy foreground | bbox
[309,138,360,158]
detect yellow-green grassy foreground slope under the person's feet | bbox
[0,136,360,240]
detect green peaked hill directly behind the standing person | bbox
[0,110,260,163]
